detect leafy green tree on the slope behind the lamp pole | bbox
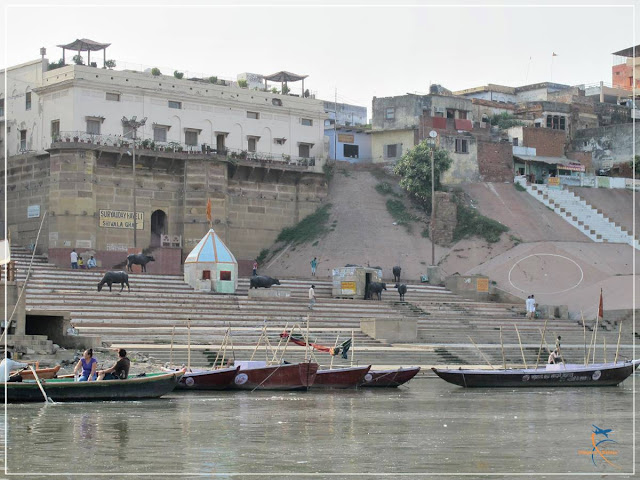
[394,140,453,208]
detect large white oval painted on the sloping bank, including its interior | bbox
[509,253,584,295]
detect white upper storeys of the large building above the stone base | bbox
[0,52,327,161]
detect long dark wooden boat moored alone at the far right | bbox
[432,360,640,388]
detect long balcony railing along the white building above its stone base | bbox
[51,131,316,167]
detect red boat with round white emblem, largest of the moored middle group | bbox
[230,361,318,390]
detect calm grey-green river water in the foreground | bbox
[0,373,639,479]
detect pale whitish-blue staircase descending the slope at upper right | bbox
[516,177,640,249]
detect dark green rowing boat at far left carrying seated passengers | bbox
[0,371,183,402]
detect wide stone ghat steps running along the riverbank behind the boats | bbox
[12,248,631,366]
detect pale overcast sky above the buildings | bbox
[0,0,640,111]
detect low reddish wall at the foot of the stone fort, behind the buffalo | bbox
[49,248,182,275]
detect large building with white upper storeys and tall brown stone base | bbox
[0,44,328,274]
